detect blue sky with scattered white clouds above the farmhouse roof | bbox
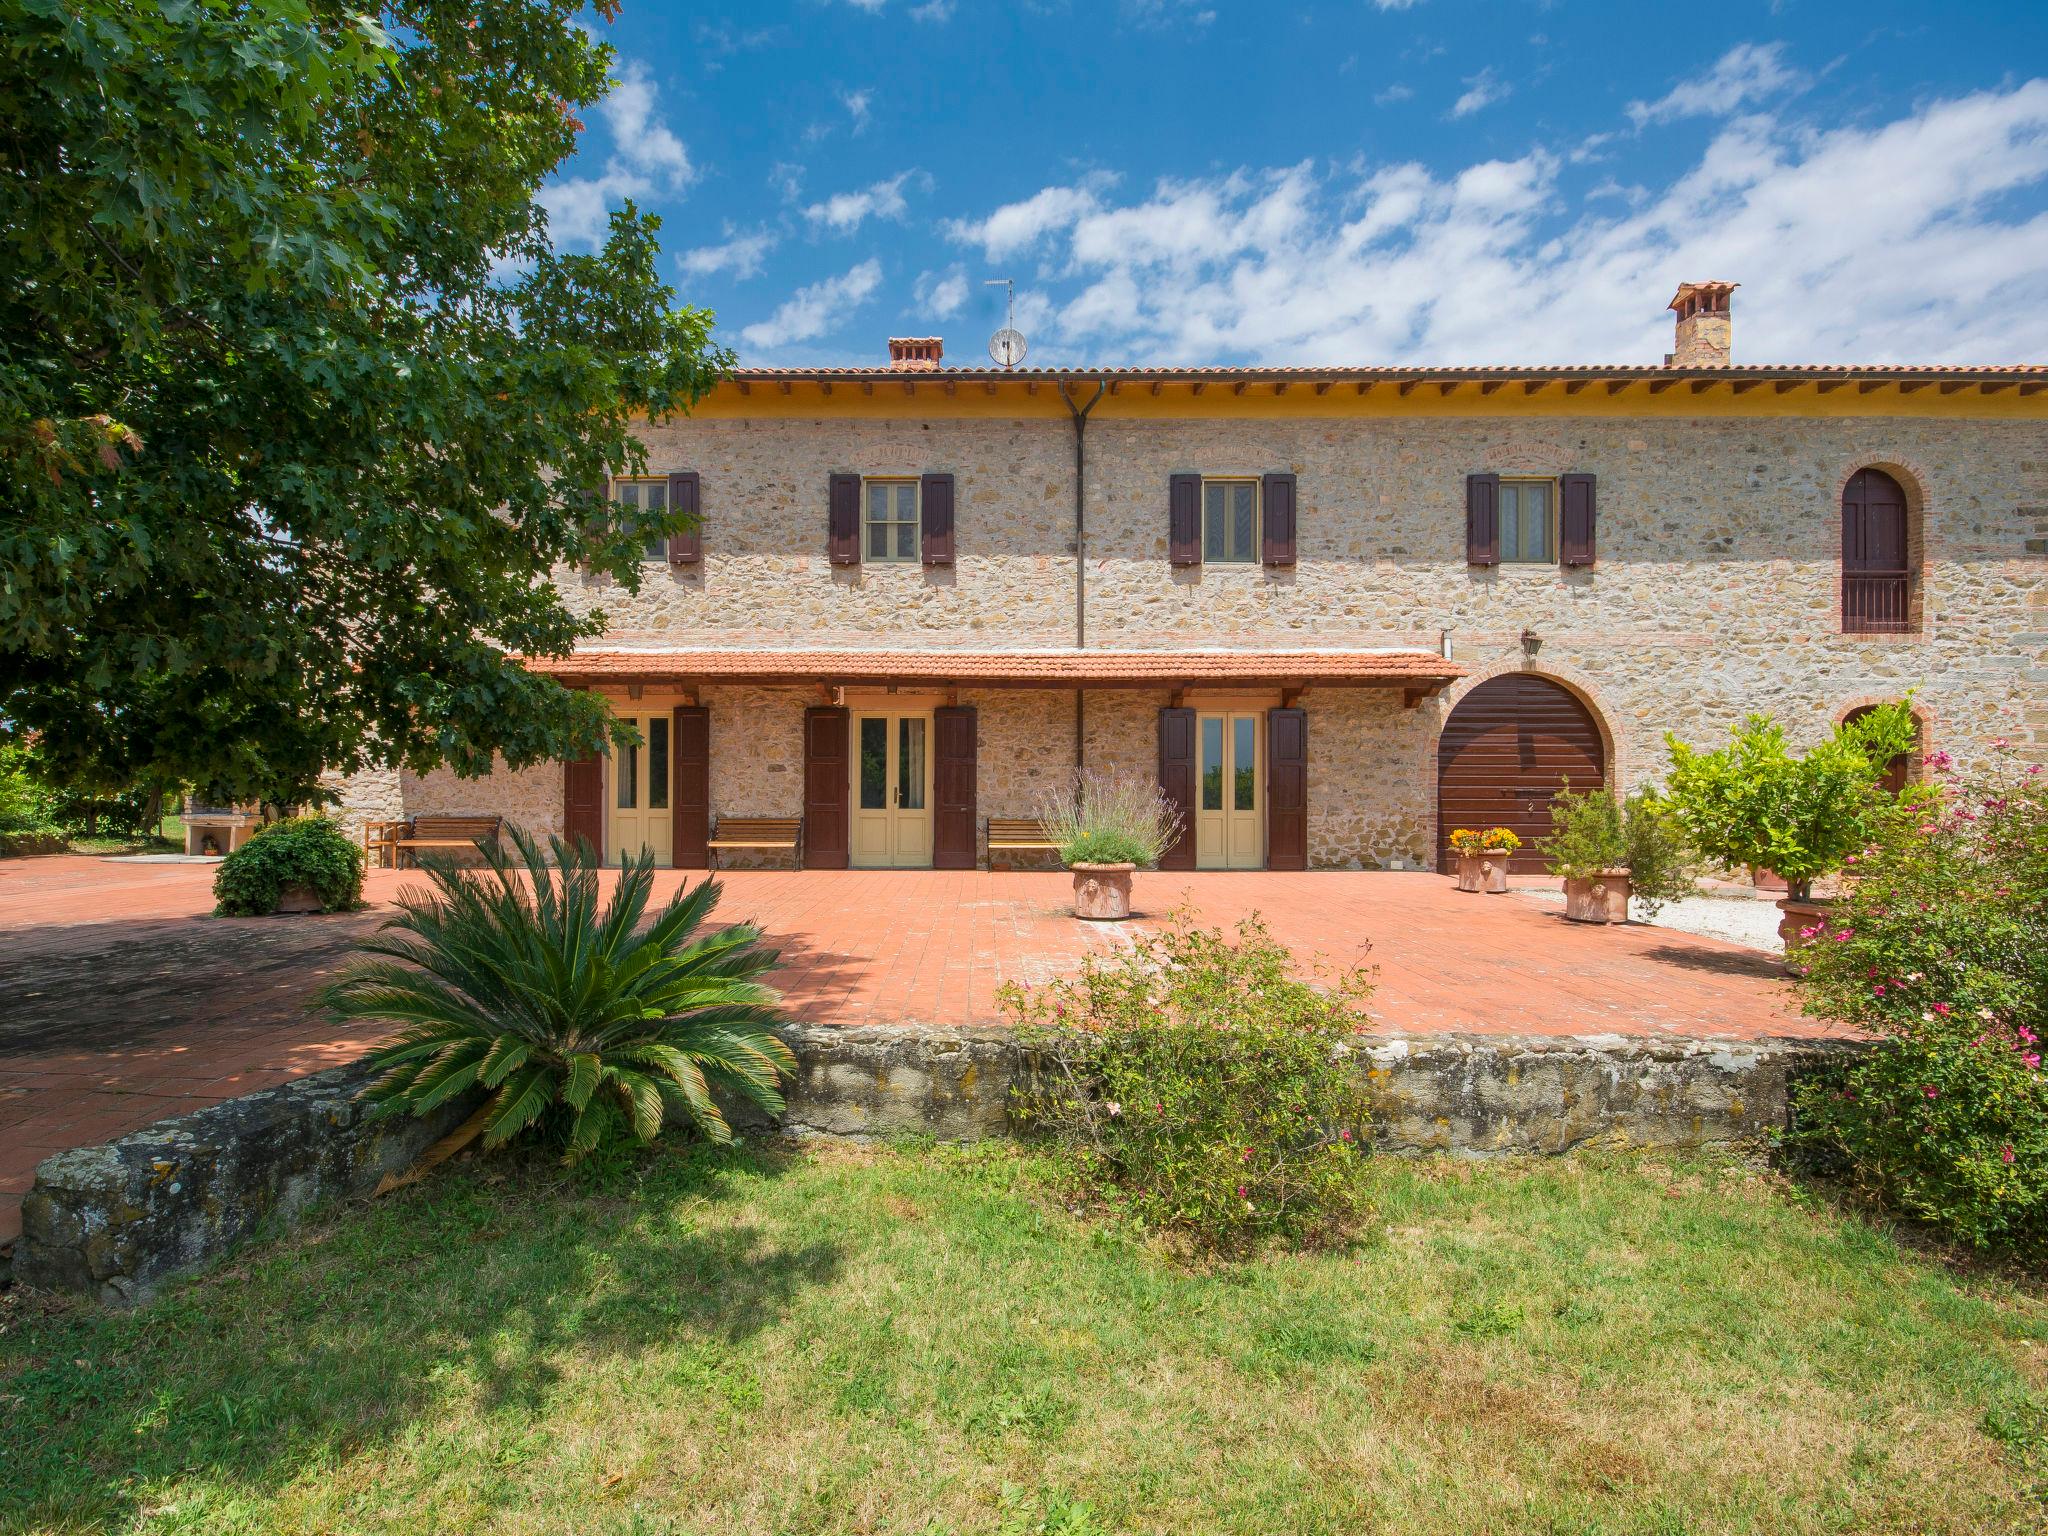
[545,0,2048,367]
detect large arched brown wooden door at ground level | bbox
[1436,672,1608,874]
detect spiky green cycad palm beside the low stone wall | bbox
[322,827,797,1161]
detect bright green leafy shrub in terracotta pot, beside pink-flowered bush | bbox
[1665,702,1917,901]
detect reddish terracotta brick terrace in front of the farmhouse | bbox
[0,858,1827,1243]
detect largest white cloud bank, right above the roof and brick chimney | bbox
[937,80,2048,365]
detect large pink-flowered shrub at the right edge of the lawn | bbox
[1788,743,2048,1253]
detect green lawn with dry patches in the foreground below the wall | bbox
[0,1149,2048,1536]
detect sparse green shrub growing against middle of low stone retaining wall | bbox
[1001,913,1370,1255]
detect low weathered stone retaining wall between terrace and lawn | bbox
[14,1026,1855,1305]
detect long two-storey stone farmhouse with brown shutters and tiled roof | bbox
[340,283,2048,870]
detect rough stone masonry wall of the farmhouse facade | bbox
[331,414,2048,866]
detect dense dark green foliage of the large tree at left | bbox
[0,0,727,799]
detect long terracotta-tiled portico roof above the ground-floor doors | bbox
[524,649,1466,694]
